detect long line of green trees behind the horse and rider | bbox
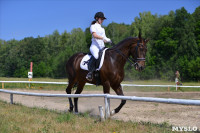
[0,6,200,81]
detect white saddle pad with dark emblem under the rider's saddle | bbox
[80,48,108,70]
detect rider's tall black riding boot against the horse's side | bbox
[86,57,97,81]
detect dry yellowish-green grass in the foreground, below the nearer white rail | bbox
[0,101,177,133]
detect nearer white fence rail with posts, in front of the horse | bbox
[0,89,200,119]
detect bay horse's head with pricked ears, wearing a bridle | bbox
[130,33,149,71]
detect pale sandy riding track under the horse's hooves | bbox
[0,90,200,128]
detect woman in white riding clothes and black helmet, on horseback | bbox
[86,12,112,81]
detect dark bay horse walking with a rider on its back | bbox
[66,34,148,115]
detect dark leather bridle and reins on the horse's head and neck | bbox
[115,40,145,67]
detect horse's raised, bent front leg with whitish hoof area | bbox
[111,84,126,116]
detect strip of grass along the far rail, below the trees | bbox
[0,77,200,92]
